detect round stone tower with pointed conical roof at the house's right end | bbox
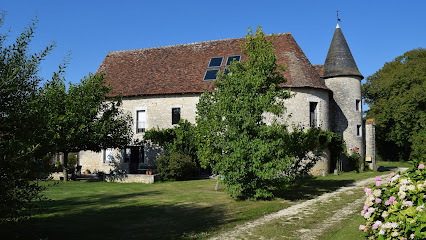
[324,24,365,170]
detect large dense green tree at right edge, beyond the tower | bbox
[362,48,426,161]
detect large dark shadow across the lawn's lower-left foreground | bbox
[0,191,225,240]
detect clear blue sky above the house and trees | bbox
[0,0,426,96]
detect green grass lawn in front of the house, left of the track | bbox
[0,161,410,240]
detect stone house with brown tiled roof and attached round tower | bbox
[79,25,374,177]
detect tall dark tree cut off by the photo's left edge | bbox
[0,12,53,221]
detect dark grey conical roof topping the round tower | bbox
[324,24,364,79]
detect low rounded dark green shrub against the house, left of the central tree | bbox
[156,153,197,181]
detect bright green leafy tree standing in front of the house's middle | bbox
[196,27,327,199]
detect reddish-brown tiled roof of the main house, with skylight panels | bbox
[97,33,328,96]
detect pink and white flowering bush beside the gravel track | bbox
[359,164,426,240]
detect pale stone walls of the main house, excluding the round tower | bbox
[79,88,330,174]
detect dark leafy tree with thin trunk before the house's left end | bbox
[40,72,133,181]
